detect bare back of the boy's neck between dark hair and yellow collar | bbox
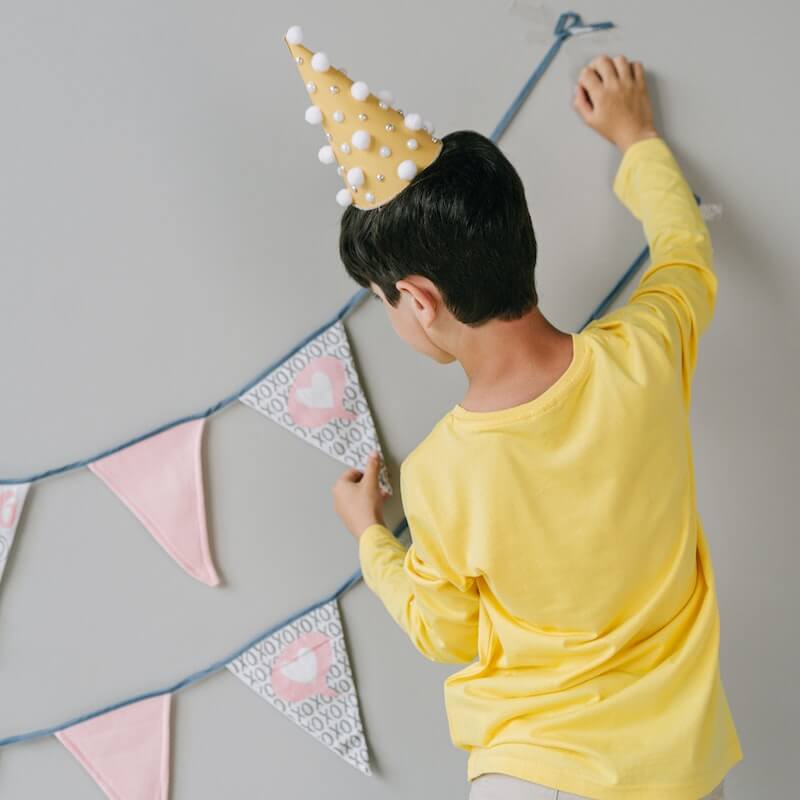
[458,308,573,411]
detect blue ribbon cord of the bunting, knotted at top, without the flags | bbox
[0,11,701,747]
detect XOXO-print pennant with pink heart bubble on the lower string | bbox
[226,598,372,775]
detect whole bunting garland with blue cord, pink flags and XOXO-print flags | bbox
[0,12,704,800]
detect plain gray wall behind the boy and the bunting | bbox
[0,0,800,800]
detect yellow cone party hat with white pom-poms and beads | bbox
[284,25,442,209]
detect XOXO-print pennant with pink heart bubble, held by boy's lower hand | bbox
[239,320,392,494]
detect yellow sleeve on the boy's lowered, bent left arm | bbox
[358,523,479,664]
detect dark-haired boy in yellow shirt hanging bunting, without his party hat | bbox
[333,55,743,800]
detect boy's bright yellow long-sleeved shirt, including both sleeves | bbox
[358,137,743,800]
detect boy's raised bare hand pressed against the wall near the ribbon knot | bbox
[572,55,659,153]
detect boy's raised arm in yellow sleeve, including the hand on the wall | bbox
[573,54,717,407]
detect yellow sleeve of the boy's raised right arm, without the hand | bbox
[613,136,717,406]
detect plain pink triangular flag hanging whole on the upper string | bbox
[89,417,219,586]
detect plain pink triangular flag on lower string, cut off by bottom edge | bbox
[56,694,172,800]
